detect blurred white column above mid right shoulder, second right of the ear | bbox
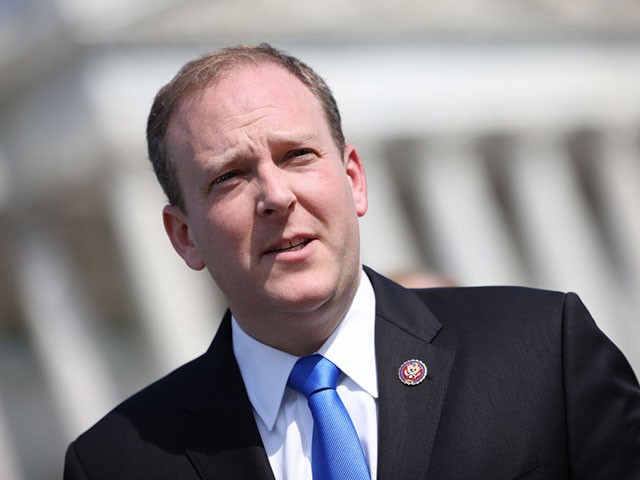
[414,139,526,284]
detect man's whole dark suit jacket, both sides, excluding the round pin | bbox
[64,270,640,480]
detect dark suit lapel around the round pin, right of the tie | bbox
[366,269,454,480]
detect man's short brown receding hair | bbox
[147,43,345,211]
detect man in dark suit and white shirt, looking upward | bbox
[65,45,640,480]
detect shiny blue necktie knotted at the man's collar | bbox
[288,355,371,480]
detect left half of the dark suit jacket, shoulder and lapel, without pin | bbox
[64,314,273,480]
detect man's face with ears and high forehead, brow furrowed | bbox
[164,63,367,333]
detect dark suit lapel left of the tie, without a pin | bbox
[178,312,274,480]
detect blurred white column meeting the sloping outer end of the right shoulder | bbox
[506,133,622,338]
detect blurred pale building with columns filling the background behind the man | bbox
[0,0,640,480]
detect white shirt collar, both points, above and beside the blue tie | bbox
[231,272,378,431]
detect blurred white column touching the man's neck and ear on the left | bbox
[108,171,224,374]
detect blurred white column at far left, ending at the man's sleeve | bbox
[14,228,117,438]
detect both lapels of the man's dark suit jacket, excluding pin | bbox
[175,269,454,480]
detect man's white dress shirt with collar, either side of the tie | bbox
[232,272,378,480]
